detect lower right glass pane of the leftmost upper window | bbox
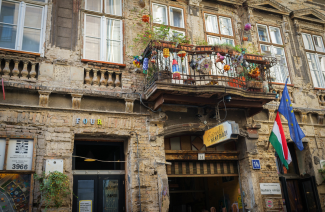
[22,28,41,52]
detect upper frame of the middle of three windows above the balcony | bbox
[202,11,236,46]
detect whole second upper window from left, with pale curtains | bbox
[83,0,123,63]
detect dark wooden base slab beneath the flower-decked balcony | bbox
[145,82,276,110]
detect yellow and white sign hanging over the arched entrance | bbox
[203,121,239,147]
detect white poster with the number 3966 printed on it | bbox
[6,139,34,171]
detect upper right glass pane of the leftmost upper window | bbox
[24,6,43,29]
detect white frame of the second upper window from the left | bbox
[81,0,125,63]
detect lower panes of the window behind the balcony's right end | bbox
[261,44,290,83]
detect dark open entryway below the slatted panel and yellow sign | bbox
[168,177,241,212]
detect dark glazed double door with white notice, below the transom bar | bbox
[72,175,125,212]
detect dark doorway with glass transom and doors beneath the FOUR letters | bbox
[72,141,125,212]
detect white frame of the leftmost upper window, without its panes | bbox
[0,0,48,57]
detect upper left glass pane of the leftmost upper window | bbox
[0,1,19,24]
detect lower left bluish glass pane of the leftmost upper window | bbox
[0,24,17,49]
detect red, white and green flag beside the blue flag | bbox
[270,112,292,169]
